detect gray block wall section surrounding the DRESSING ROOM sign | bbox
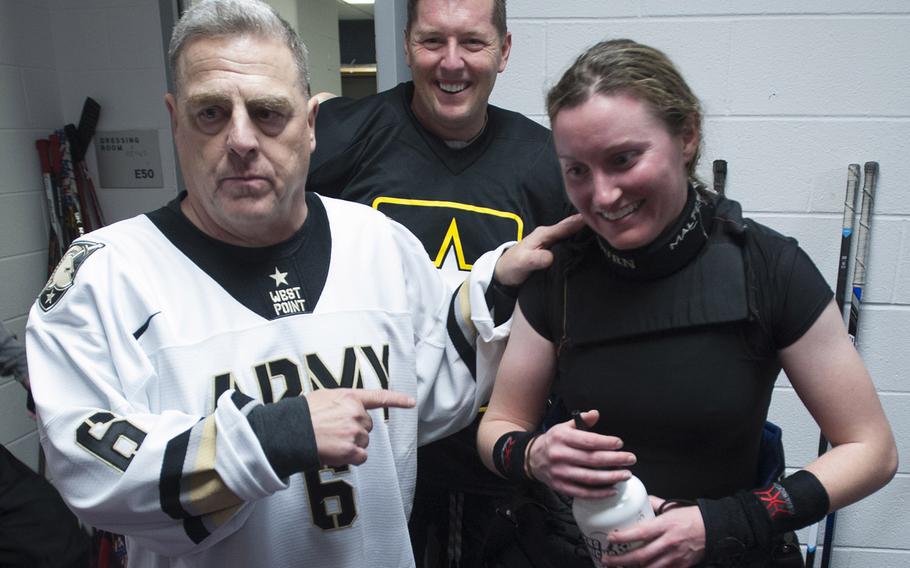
[49,0,177,223]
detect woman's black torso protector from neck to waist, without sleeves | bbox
[548,192,780,498]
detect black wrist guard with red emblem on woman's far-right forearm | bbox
[698,471,829,566]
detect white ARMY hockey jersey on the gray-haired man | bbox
[27,194,507,568]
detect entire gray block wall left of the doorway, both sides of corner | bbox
[0,0,177,468]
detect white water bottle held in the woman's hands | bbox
[572,475,654,568]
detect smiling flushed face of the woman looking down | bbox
[553,93,699,250]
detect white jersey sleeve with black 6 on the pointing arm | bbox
[27,236,287,555]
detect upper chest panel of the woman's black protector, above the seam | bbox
[566,192,749,344]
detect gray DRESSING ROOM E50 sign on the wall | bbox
[95,130,164,189]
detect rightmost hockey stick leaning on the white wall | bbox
[821,162,878,568]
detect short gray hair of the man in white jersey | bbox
[167,0,310,96]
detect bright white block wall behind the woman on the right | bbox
[492,0,910,568]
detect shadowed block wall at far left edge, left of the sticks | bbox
[0,0,63,469]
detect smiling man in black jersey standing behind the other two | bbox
[307,0,569,567]
